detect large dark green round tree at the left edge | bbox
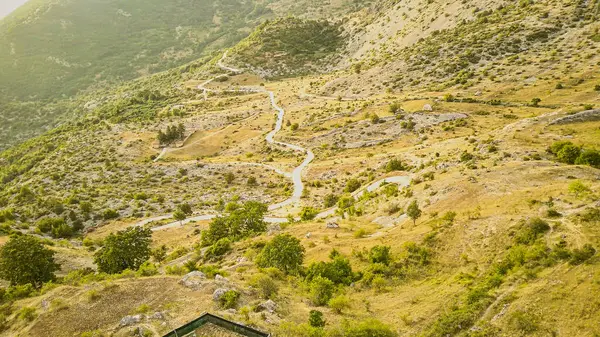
[0,235,60,288]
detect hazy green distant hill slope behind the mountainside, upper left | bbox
[0,0,270,99]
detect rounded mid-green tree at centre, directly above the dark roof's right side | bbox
[257,234,304,274]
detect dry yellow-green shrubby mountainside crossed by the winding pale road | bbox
[0,0,600,337]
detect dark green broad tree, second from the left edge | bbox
[94,227,152,274]
